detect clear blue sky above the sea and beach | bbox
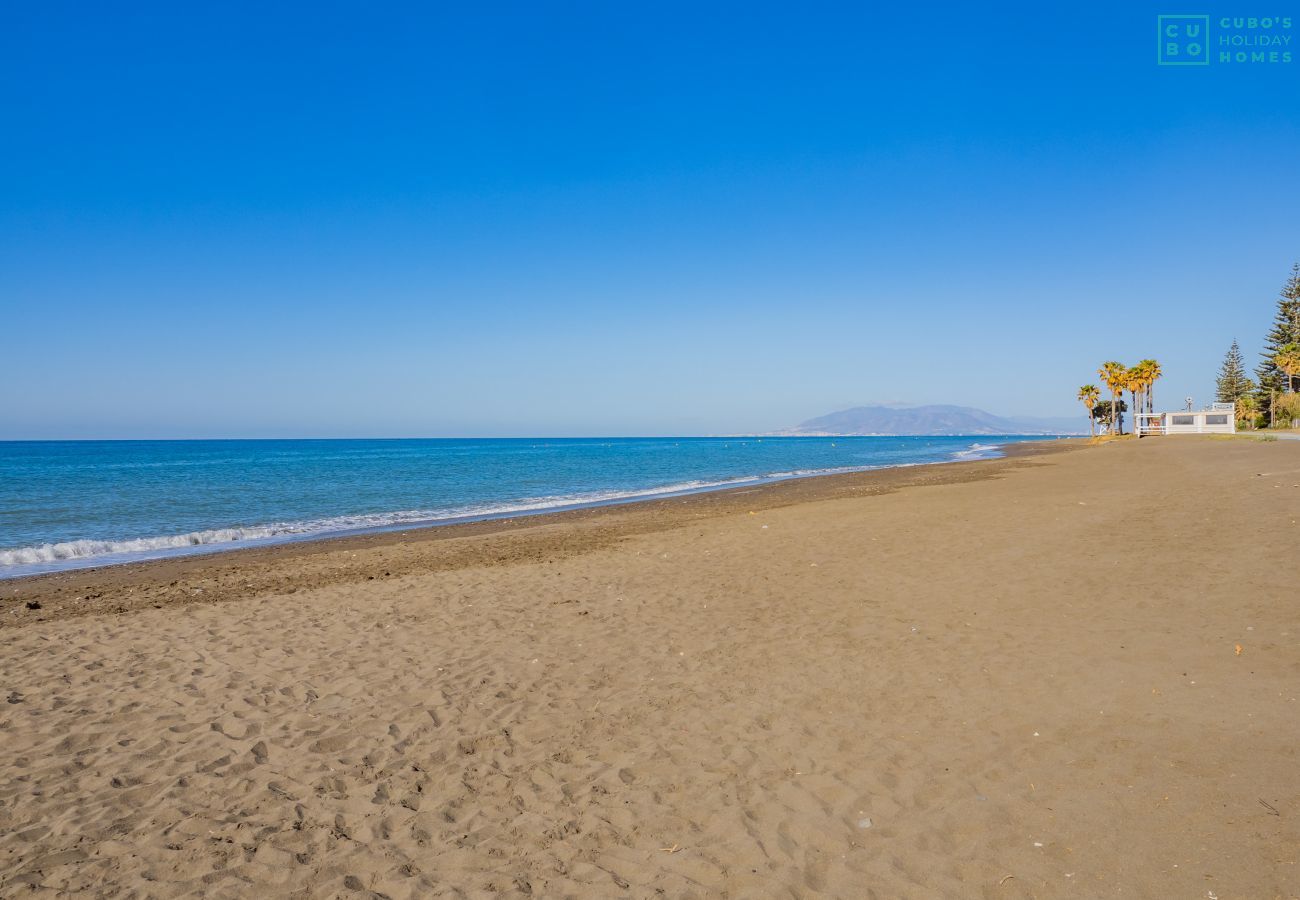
[0,0,1300,438]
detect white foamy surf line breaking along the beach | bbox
[0,443,997,579]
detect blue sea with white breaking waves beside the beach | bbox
[0,436,1060,577]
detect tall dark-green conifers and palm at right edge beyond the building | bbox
[1216,264,1300,428]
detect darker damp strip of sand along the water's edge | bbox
[0,437,1087,628]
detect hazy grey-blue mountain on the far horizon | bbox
[781,406,1087,436]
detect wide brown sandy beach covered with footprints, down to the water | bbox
[0,437,1300,900]
